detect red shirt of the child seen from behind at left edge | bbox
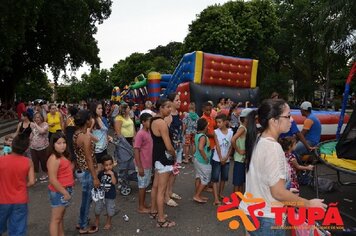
[0,154,31,204]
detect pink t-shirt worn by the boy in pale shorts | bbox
[134,129,153,169]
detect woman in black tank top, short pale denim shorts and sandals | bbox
[150,98,176,228]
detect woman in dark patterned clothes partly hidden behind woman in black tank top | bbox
[164,93,183,207]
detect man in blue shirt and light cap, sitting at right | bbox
[295,101,321,160]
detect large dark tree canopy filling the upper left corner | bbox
[0,0,112,103]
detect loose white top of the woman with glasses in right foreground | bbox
[239,137,289,218]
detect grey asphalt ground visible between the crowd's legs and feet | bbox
[28,162,243,235]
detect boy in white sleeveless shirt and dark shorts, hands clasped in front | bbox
[211,114,232,206]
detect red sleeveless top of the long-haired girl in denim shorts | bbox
[48,157,74,192]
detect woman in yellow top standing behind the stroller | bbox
[114,103,136,146]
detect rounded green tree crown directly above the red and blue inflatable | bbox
[185,0,279,81]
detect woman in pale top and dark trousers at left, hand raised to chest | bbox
[30,112,49,181]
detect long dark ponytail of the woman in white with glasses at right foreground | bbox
[245,110,257,171]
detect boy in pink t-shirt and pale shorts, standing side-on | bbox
[134,113,153,213]
